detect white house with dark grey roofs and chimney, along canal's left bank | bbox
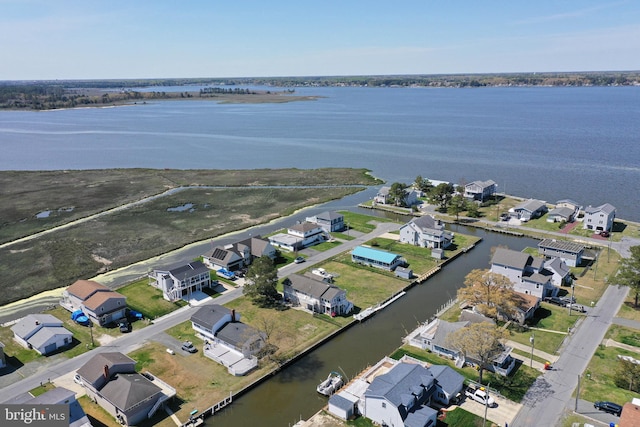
[191,304,267,375]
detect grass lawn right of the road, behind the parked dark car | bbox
[580,345,640,405]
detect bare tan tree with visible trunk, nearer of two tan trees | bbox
[447,322,506,383]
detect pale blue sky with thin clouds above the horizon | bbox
[0,0,640,80]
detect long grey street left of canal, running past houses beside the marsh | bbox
[0,223,400,402]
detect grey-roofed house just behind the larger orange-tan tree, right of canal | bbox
[491,248,558,298]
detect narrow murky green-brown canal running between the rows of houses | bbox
[207,222,537,427]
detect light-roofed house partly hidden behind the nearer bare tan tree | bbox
[403,319,516,376]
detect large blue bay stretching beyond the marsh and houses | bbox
[0,87,640,221]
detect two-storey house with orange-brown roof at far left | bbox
[60,280,127,326]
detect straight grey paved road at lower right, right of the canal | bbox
[509,286,629,427]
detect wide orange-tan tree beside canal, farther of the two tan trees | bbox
[458,269,522,320]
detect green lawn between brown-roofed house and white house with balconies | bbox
[118,278,187,319]
